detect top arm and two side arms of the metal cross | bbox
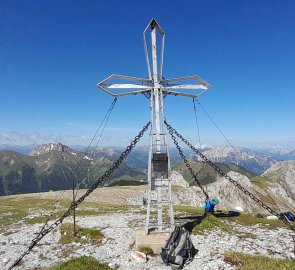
[97,19,210,98]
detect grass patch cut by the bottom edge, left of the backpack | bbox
[48,256,113,270]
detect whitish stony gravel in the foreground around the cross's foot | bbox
[0,205,295,270]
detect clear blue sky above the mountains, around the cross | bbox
[0,0,295,149]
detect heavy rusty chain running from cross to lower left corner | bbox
[8,122,150,270]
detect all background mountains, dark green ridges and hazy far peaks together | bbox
[0,143,295,195]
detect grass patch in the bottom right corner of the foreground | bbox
[224,252,295,270]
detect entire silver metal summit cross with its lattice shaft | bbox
[97,19,210,233]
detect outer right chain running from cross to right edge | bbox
[164,120,295,236]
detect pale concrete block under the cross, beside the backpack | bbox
[135,229,170,254]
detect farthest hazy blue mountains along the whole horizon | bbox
[0,144,295,169]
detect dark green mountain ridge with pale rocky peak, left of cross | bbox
[0,144,146,195]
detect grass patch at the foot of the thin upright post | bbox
[59,223,104,245]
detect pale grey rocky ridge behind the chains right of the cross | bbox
[173,172,295,213]
